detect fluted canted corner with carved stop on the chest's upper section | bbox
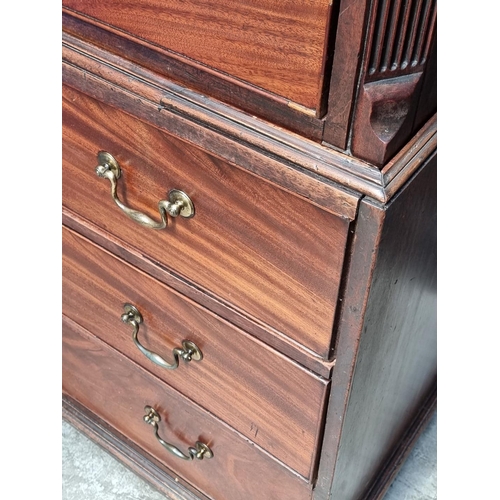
[340,0,436,167]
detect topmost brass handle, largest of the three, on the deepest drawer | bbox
[95,151,194,229]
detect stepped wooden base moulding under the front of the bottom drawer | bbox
[62,395,209,500]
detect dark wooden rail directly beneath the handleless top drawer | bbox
[62,7,324,141]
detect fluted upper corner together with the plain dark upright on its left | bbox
[323,0,437,167]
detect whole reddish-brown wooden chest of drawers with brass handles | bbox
[62,0,436,500]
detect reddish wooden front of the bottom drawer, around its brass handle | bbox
[63,317,311,500]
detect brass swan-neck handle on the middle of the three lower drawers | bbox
[121,304,203,370]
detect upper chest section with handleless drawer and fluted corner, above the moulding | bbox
[63,0,437,158]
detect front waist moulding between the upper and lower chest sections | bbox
[63,33,381,203]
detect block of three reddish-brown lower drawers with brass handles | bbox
[62,76,349,500]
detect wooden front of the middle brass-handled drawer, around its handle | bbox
[63,225,328,478]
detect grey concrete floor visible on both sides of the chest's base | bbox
[62,415,437,500]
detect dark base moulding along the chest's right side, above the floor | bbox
[360,384,437,500]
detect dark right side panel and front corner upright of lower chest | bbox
[316,155,437,499]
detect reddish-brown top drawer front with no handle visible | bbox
[63,0,332,109]
